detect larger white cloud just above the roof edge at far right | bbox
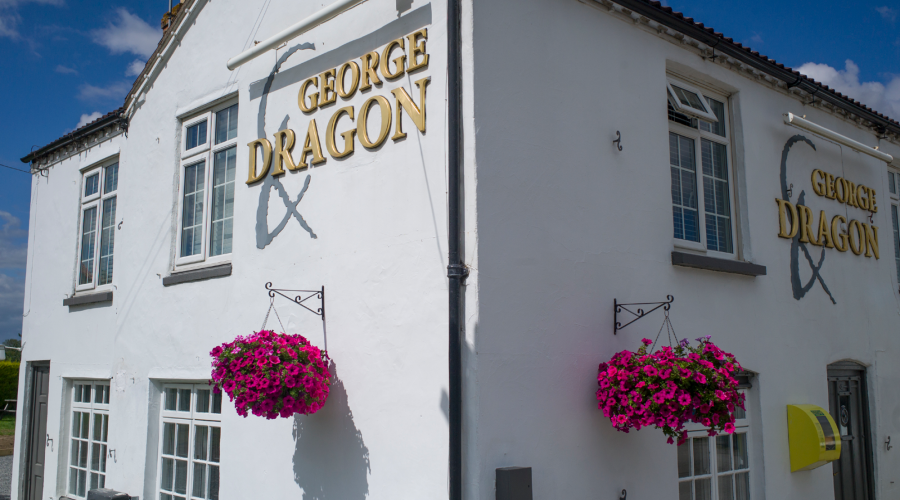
[797,59,900,119]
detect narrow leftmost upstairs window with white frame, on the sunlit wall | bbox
[75,156,119,291]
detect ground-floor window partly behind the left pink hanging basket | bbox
[159,384,222,500]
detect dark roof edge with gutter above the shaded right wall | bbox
[611,0,900,135]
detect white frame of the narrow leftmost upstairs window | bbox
[75,156,121,292]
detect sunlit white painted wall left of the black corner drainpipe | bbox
[20,0,447,500]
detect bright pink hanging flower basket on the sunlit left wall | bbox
[209,330,331,419]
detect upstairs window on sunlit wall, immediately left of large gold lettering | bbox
[176,100,238,266]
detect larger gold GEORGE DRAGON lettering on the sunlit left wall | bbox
[247,28,430,184]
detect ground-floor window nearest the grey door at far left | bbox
[68,380,109,498]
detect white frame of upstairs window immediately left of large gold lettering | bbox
[175,99,240,271]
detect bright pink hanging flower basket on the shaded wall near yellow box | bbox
[597,336,744,444]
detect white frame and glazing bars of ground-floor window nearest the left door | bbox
[65,380,110,499]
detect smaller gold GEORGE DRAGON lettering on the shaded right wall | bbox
[775,169,879,259]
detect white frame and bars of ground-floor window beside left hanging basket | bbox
[154,382,222,500]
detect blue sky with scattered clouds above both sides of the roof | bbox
[0,0,900,340]
